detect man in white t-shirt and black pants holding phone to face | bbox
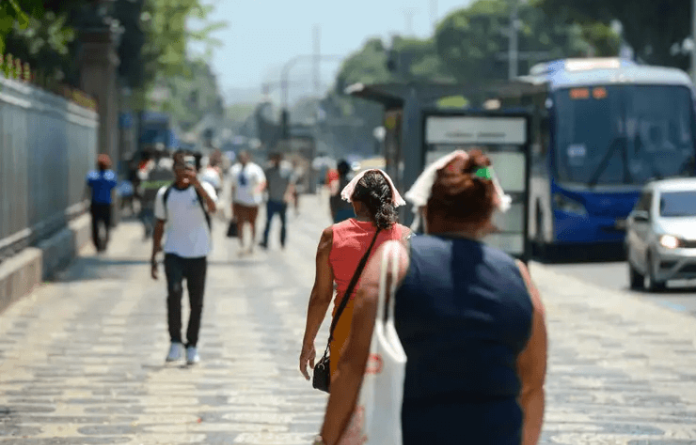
[152,154,217,365]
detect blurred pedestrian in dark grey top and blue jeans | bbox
[260,153,295,249]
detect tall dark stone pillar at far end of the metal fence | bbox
[80,26,121,224]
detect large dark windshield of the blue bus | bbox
[554,85,696,186]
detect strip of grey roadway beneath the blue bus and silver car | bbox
[549,261,696,316]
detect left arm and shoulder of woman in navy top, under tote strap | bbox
[321,243,409,445]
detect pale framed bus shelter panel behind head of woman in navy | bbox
[423,110,531,261]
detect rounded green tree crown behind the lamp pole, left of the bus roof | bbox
[435,0,618,83]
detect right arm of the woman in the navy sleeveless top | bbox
[517,262,548,445]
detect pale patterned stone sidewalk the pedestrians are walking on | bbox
[0,197,696,445]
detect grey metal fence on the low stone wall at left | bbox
[0,75,98,261]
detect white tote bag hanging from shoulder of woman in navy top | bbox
[340,242,406,445]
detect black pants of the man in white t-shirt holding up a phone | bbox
[164,253,208,346]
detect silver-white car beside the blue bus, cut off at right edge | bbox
[626,178,696,292]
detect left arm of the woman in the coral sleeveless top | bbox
[300,227,334,380]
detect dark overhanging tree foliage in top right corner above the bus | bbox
[539,0,693,69]
